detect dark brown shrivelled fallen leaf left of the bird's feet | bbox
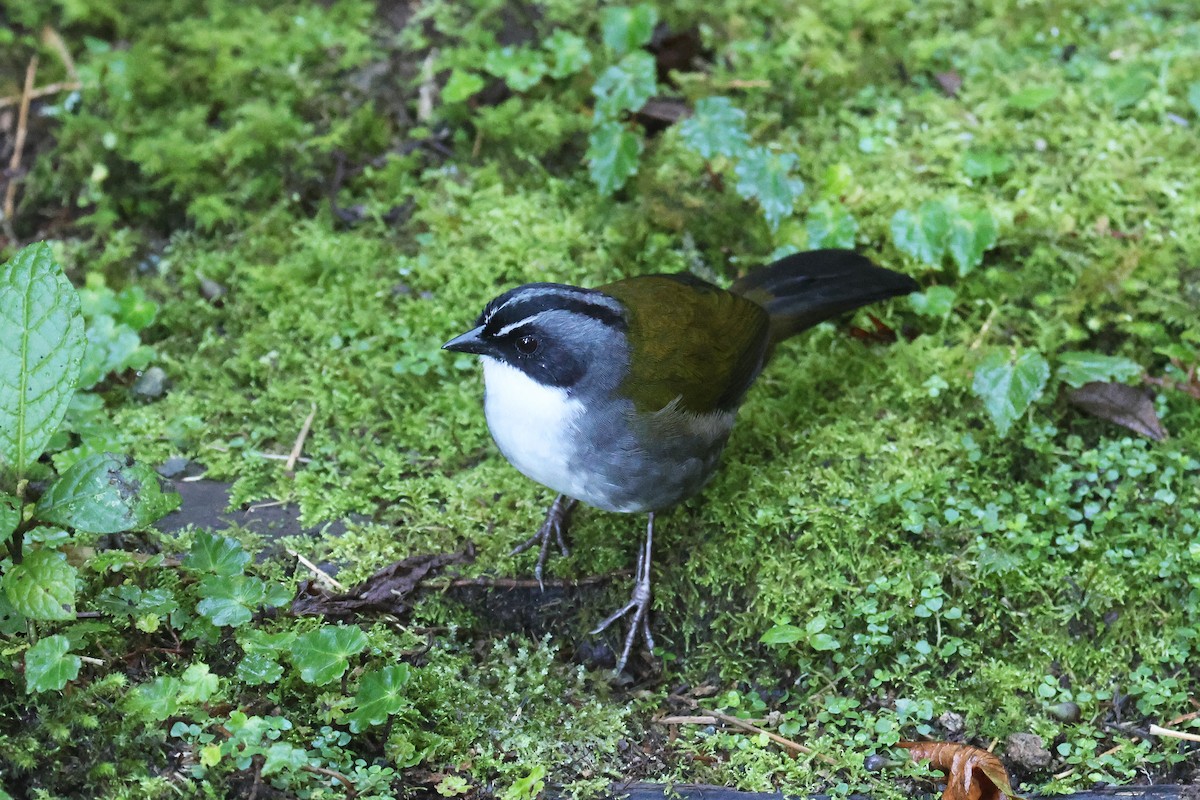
[292,545,475,619]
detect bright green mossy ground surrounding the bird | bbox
[0,0,1200,798]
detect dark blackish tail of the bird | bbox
[731,249,918,345]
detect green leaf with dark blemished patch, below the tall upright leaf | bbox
[34,453,179,534]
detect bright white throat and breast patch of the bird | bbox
[482,355,583,498]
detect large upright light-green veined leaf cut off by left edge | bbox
[0,242,85,474]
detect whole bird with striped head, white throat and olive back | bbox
[443,249,918,674]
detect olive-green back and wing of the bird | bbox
[599,273,770,414]
